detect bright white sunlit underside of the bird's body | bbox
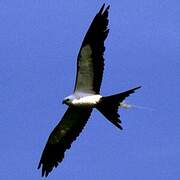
[72,95,102,106]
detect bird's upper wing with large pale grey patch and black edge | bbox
[74,4,109,94]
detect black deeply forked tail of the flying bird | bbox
[96,86,141,129]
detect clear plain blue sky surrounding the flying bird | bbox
[0,0,180,180]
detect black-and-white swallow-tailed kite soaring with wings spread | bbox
[38,4,140,177]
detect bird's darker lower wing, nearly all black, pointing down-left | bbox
[38,107,92,177]
